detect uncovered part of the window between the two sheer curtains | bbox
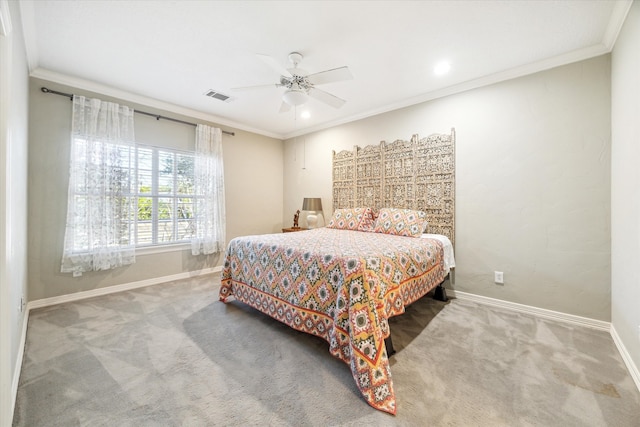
[135,144,198,247]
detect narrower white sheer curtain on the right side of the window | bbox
[191,125,225,255]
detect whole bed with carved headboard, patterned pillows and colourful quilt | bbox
[219,130,455,414]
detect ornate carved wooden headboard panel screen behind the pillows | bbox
[333,129,456,243]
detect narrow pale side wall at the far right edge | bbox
[611,2,640,385]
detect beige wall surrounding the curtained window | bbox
[29,78,283,301]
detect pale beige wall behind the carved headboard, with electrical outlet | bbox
[284,55,611,321]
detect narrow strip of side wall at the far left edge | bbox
[0,2,29,425]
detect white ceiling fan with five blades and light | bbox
[232,52,353,113]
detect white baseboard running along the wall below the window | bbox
[27,266,222,310]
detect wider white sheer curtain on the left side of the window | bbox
[61,96,137,276]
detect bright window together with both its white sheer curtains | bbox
[60,96,225,276]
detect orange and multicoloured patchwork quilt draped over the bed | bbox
[219,228,446,414]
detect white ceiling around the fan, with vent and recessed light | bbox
[21,0,631,138]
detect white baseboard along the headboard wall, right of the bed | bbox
[447,289,611,332]
